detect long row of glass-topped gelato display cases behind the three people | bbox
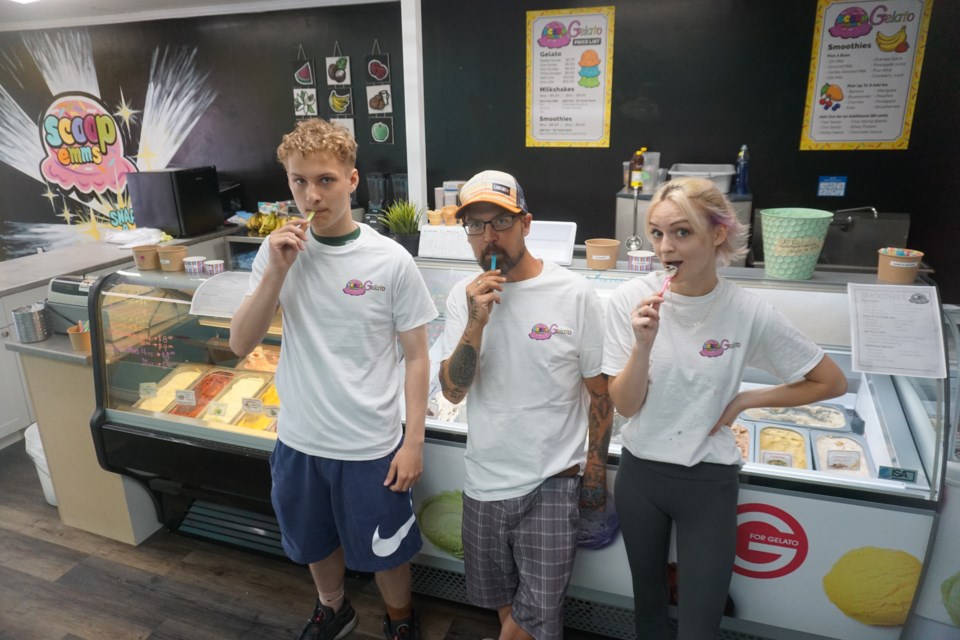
[90,259,960,640]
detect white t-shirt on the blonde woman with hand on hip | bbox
[603,272,824,466]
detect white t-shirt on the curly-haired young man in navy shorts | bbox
[250,224,437,460]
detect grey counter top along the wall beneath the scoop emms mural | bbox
[0,225,237,296]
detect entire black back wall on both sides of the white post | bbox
[0,0,960,303]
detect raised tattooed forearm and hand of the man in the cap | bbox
[440,271,505,404]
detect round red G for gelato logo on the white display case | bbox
[733,502,810,579]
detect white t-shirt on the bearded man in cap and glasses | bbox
[443,261,603,501]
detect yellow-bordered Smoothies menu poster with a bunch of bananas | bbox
[800,0,933,151]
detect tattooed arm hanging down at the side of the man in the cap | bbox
[580,374,613,511]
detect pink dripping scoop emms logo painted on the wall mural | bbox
[40,93,137,228]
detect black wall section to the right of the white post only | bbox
[423,0,960,302]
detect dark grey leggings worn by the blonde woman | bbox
[614,449,740,640]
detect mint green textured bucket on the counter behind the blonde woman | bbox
[760,208,833,280]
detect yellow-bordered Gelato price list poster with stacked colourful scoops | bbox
[527,7,614,147]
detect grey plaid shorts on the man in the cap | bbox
[463,476,580,640]
